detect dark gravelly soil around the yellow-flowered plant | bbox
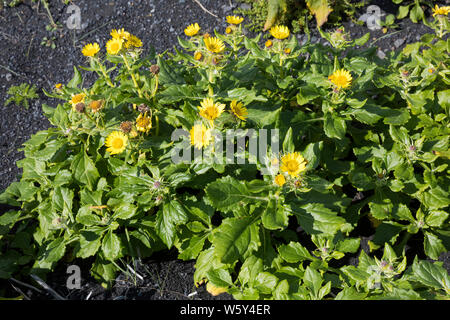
[0,0,450,300]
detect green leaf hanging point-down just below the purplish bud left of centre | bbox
[156,200,188,249]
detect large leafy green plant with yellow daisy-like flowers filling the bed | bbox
[0,10,450,299]
